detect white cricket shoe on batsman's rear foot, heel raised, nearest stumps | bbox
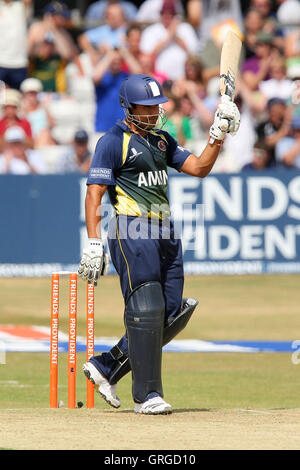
[83,362,121,408]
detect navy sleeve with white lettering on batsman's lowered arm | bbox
[87,134,122,186]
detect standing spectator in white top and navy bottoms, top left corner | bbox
[0,0,32,89]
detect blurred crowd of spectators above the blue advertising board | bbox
[0,0,300,174]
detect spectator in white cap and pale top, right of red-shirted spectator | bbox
[21,78,55,148]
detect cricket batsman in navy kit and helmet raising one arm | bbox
[78,74,240,415]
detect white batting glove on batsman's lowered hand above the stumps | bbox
[78,238,108,286]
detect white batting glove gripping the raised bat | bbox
[209,95,241,140]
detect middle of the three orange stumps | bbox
[68,273,77,409]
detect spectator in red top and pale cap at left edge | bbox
[0,88,33,151]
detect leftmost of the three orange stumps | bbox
[50,274,59,408]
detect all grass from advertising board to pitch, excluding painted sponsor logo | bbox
[0,275,300,410]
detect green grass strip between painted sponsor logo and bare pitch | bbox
[0,353,300,411]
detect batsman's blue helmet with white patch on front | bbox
[119,73,168,109]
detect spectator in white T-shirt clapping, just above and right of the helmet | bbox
[141,0,198,80]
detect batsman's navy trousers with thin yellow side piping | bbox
[92,215,184,379]
